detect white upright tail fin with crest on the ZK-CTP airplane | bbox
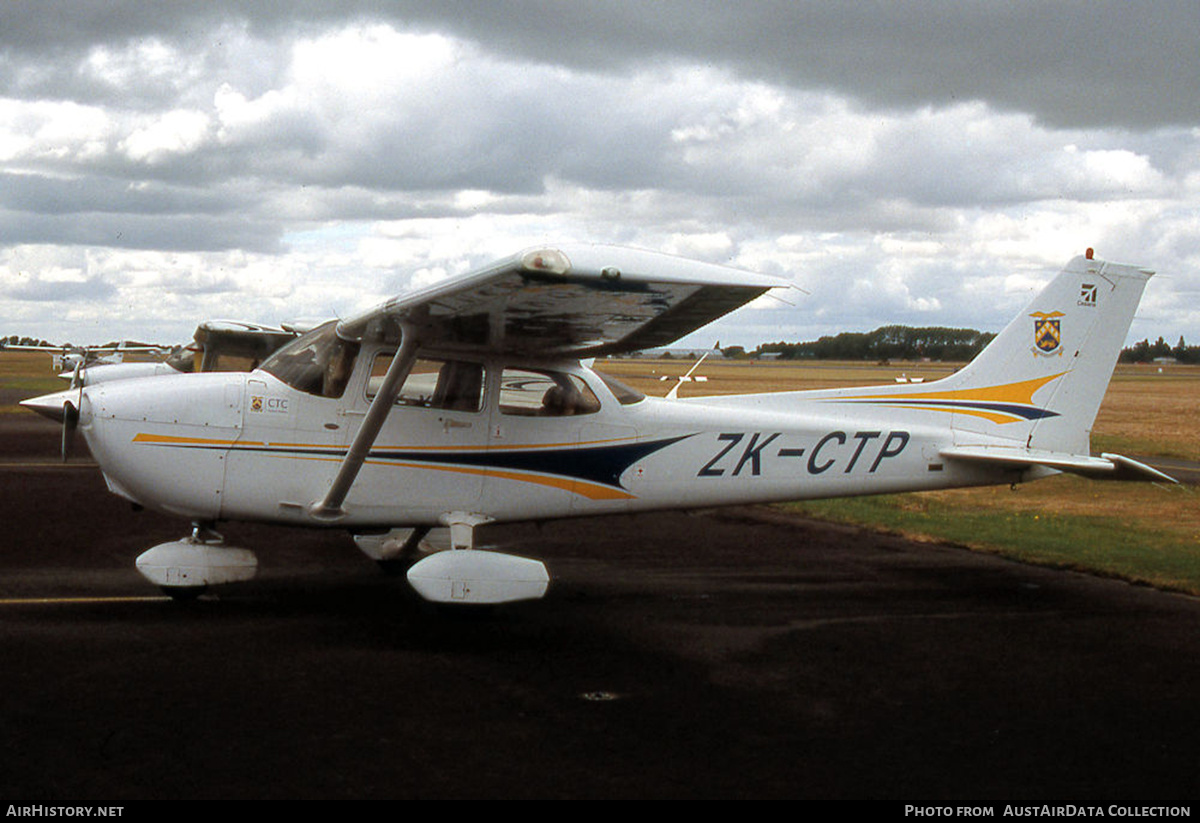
[938,253,1153,455]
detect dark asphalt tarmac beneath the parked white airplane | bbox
[0,415,1200,801]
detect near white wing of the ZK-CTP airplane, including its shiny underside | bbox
[338,245,790,358]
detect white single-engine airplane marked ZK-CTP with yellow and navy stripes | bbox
[24,245,1170,603]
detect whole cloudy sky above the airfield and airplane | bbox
[0,0,1200,348]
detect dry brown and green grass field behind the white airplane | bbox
[0,353,1200,594]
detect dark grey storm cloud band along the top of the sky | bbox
[0,0,1200,130]
